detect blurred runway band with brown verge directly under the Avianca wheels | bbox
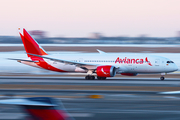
[0,76,180,91]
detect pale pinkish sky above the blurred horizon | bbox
[0,0,180,37]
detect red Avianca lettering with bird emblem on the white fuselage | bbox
[115,57,152,66]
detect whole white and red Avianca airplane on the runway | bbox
[9,28,178,80]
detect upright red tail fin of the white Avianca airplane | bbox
[19,28,48,57]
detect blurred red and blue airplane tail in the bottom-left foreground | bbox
[0,97,74,120]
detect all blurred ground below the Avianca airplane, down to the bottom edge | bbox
[0,77,180,120]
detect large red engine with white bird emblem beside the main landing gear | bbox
[96,65,116,77]
